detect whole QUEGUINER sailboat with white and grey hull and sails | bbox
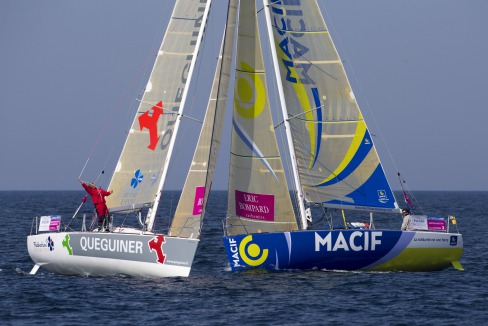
[27,0,233,277]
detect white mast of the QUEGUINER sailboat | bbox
[146,0,212,231]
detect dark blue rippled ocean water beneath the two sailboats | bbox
[0,191,488,325]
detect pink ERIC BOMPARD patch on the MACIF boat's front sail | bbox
[235,190,274,221]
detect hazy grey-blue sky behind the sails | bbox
[0,0,488,190]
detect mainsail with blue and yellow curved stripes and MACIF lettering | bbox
[269,0,398,211]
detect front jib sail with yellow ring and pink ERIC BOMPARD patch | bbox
[226,0,298,235]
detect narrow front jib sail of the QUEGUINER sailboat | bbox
[169,0,238,238]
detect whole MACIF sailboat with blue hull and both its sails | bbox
[224,0,463,271]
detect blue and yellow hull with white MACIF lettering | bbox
[224,230,463,271]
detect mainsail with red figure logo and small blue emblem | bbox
[107,0,210,224]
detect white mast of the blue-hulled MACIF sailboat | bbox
[263,0,308,230]
